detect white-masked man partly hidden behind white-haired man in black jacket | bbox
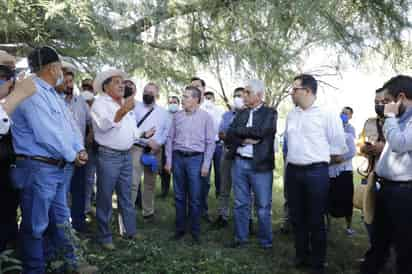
[213,87,245,229]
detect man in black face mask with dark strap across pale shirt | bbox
[132,83,171,221]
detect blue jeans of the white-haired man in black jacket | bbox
[232,157,273,247]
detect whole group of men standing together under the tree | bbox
[0,47,412,274]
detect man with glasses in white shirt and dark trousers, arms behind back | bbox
[285,74,347,274]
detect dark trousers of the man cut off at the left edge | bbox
[0,165,19,252]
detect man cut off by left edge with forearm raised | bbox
[0,51,36,252]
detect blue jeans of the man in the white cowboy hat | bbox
[96,147,136,243]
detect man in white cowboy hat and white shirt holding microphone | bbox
[91,69,154,250]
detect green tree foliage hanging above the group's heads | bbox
[0,0,411,105]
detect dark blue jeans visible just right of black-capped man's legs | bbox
[70,166,86,232]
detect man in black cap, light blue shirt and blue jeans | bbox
[11,47,96,273]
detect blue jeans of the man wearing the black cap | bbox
[13,160,78,274]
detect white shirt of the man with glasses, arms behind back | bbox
[285,105,347,165]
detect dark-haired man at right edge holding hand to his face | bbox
[361,75,412,274]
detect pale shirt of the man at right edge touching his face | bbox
[375,108,412,181]
